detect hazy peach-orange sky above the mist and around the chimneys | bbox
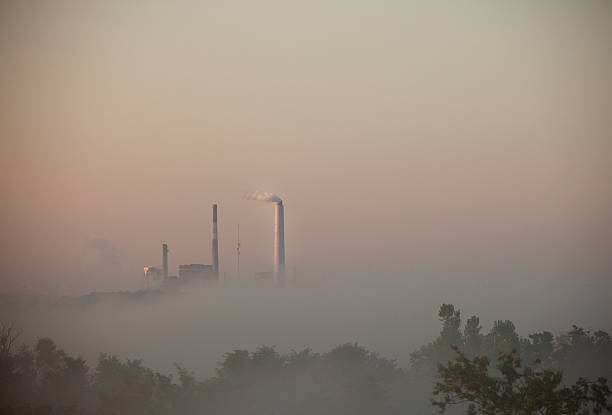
[0,1,612,292]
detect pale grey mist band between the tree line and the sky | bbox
[0,270,612,378]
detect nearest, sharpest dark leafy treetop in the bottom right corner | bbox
[432,346,612,415]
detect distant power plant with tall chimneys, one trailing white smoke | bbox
[144,192,285,288]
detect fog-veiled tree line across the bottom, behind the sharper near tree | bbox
[0,304,612,415]
